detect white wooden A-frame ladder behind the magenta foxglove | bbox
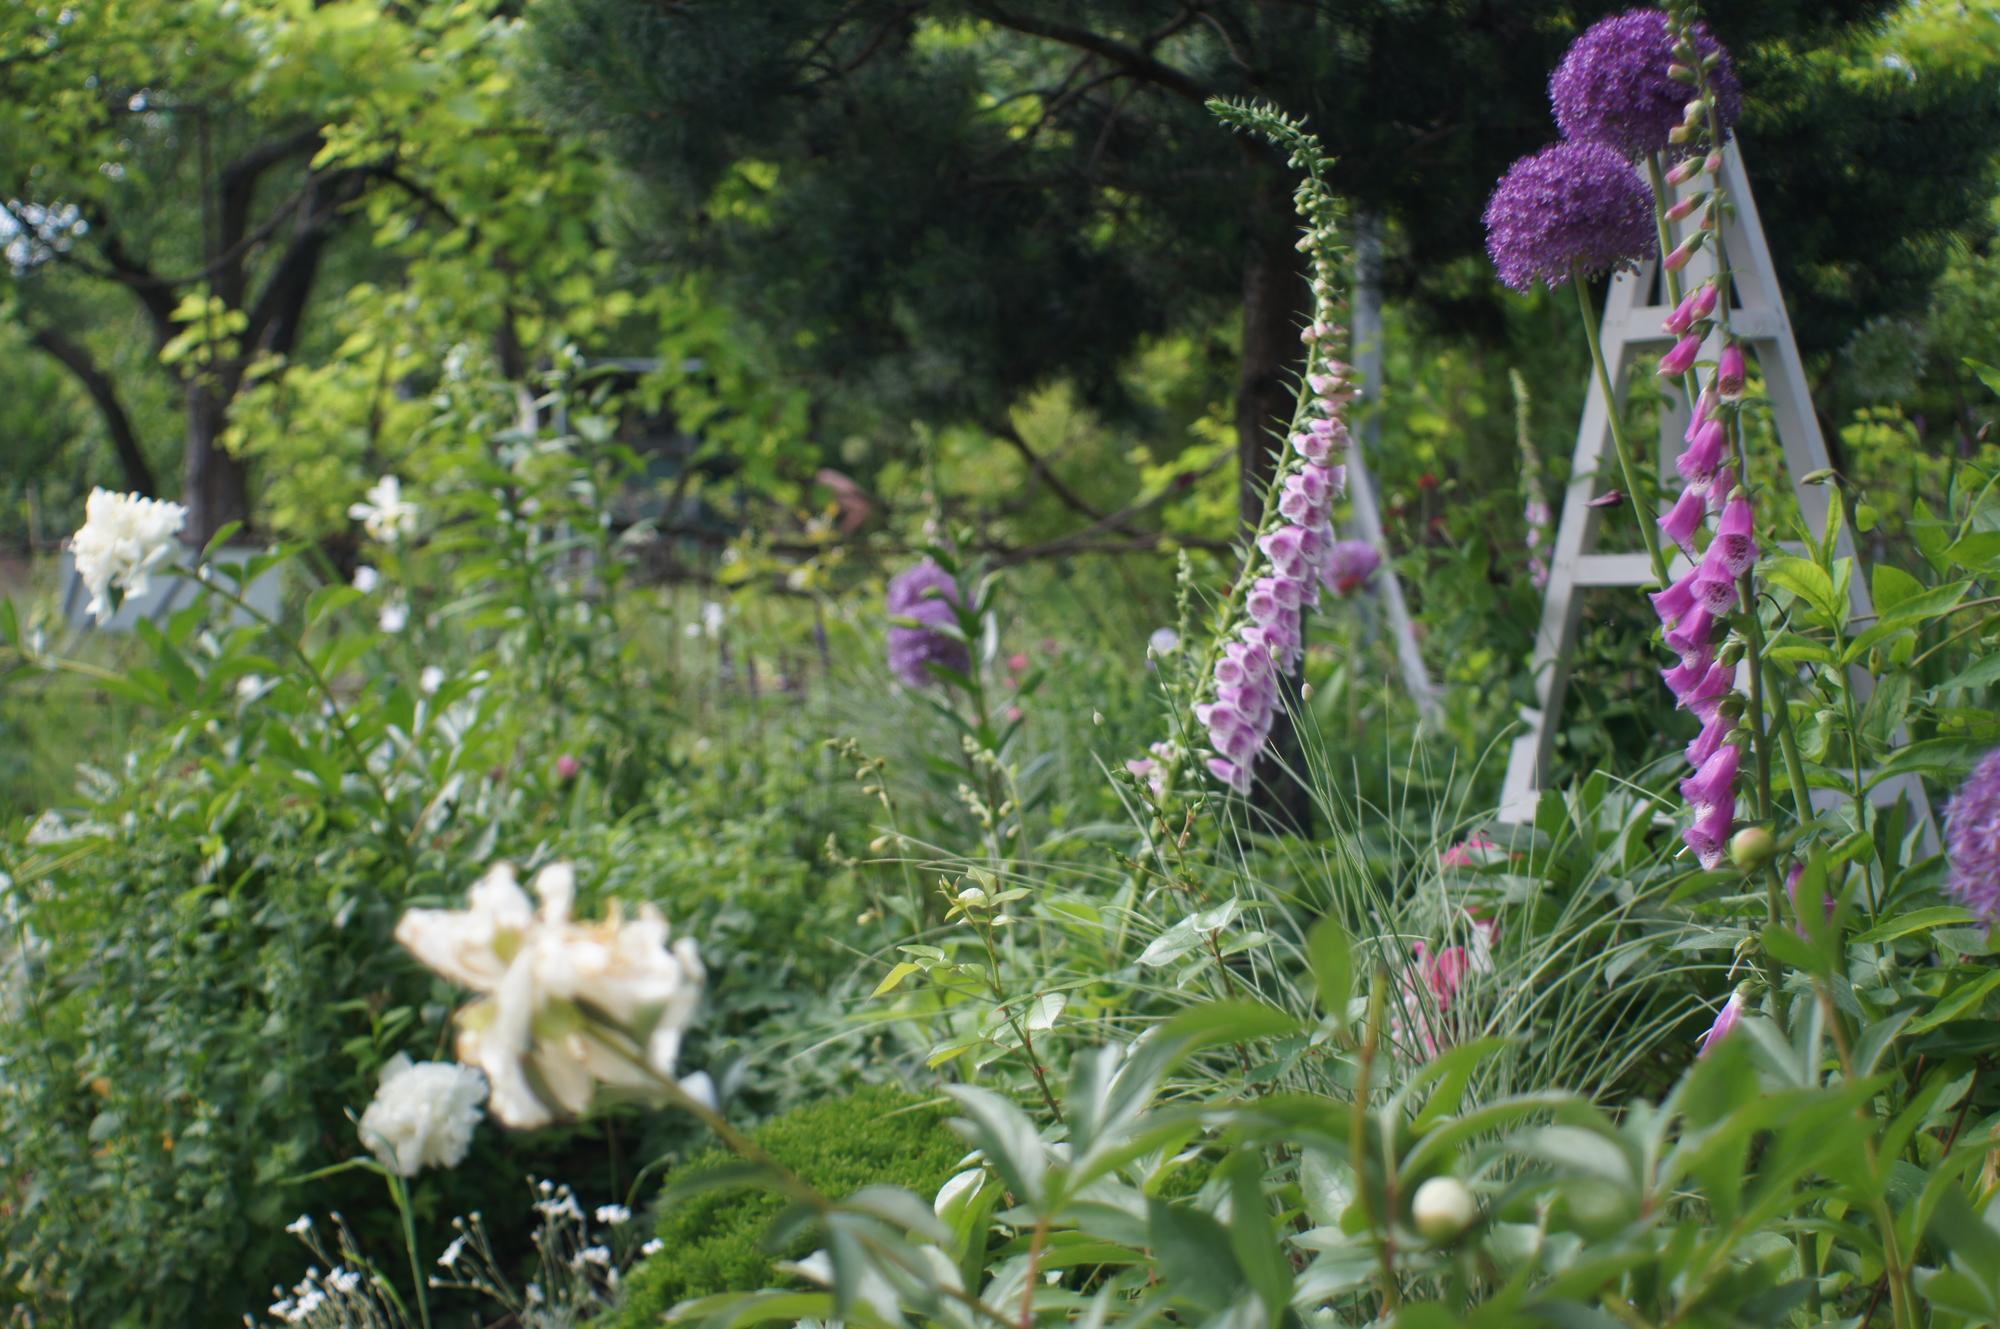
[1500,142,1934,843]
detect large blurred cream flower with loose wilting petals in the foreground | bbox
[396,863,704,1127]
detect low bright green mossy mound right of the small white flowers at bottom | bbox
[604,1085,966,1329]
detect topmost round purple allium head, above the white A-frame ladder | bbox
[1548,10,1744,160]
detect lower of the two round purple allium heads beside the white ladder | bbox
[1484,142,1660,294]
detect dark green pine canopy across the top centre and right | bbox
[530,0,2000,520]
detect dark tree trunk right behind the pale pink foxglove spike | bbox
[1236,160,1312,835]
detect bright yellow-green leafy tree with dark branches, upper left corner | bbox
[0,0,632,540]
